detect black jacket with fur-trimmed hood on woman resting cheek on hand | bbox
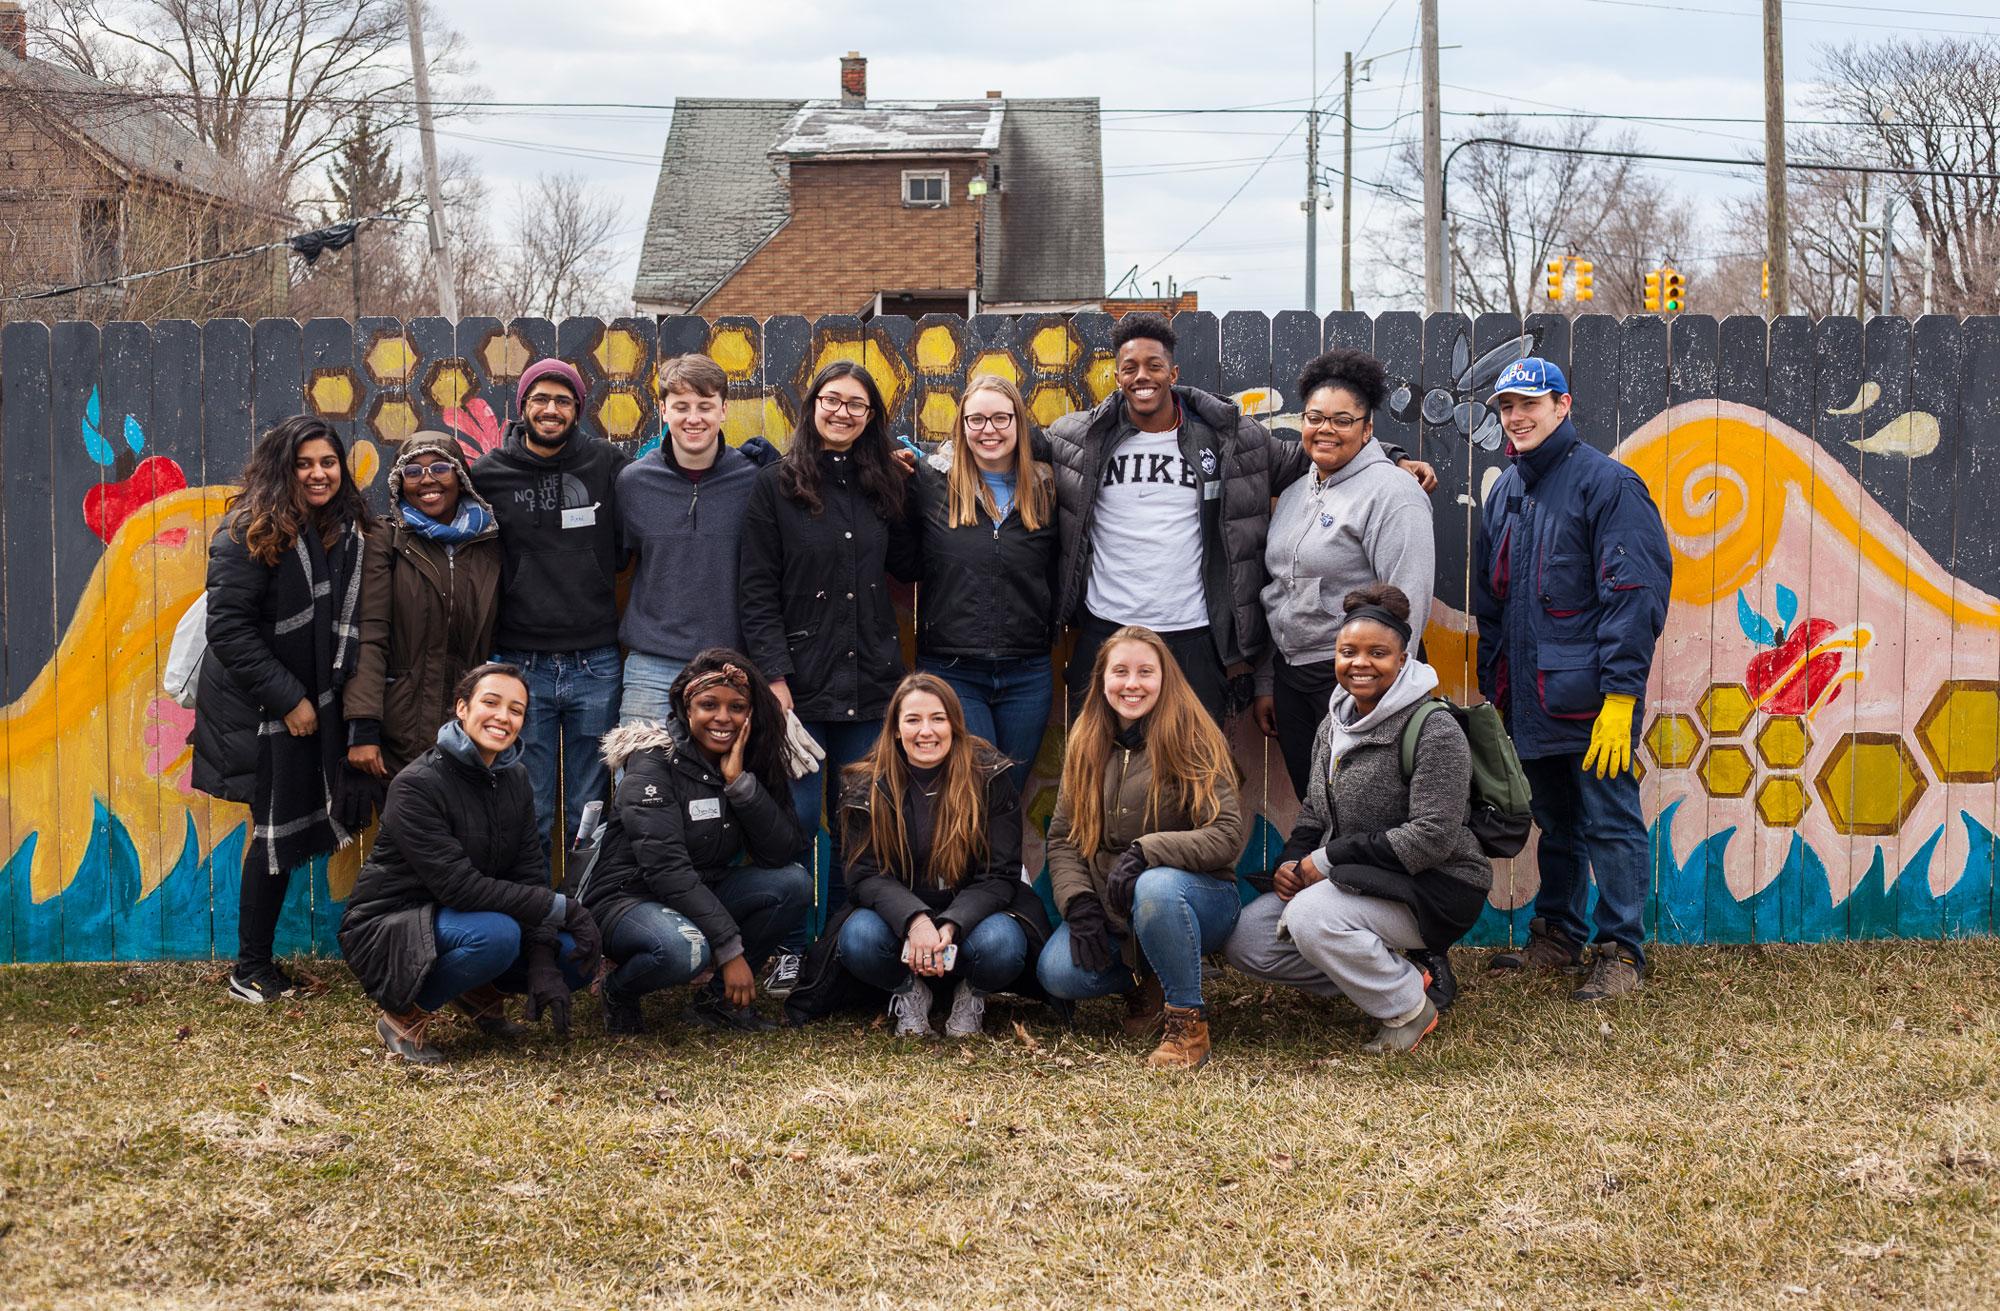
[578,715,798,965]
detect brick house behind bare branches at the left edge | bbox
[0,0,288,320]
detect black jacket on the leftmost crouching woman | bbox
[340,723,556,1011]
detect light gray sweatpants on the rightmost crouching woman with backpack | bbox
[1224,879,1424,1019]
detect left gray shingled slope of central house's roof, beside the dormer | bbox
[632,100,806,306]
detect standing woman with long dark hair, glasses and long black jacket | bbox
[738,360,916,995]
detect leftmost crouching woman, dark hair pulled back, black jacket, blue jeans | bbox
[340,663,598,1063]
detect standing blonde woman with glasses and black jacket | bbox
[914,374,1062,791]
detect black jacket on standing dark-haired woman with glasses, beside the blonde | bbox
[736,452,918,721]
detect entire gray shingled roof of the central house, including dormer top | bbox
[632,98,1104,306]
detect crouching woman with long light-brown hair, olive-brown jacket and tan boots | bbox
[1038,628,1244,1069]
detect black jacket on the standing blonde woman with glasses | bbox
[916,448,1062,659]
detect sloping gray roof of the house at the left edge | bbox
[0,50,242,200]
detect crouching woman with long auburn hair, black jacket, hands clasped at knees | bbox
[820,673,1048,1037]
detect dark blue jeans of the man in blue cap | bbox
[1520,751,1652,963]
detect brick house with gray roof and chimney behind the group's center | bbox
[632,54,1104,318]
